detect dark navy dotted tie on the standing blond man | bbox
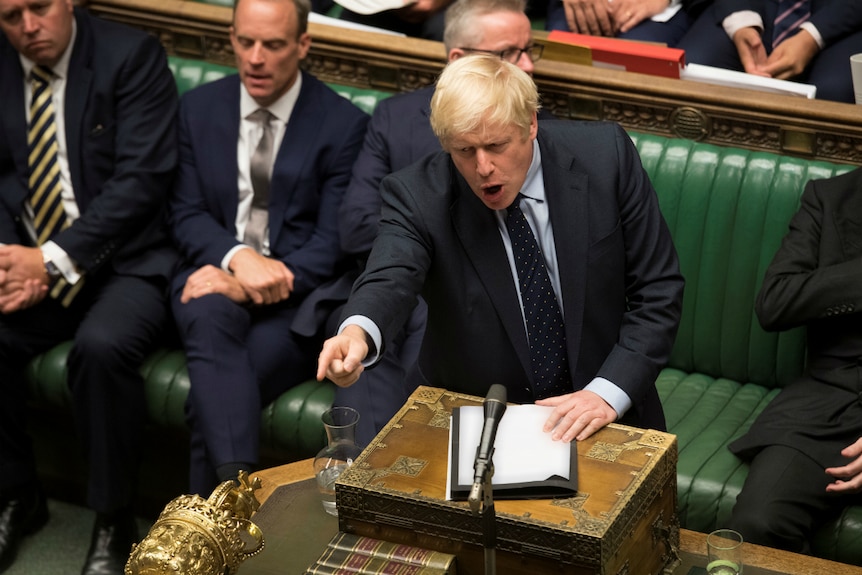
[506,194,572,399]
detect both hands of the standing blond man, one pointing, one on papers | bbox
[317,325,617,442]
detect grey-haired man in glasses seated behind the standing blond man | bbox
[335,0,551,446]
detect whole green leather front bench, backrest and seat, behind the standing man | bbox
[25,58,862,565]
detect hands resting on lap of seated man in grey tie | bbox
[180,248,294,305]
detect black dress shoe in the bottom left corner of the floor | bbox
[0,486,48,573]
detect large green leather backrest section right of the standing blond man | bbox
[631,133,852,387]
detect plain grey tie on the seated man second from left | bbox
[243,108,273,253]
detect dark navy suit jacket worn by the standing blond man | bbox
[343,120,683,429]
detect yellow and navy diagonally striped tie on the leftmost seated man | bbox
[27,66,84,307]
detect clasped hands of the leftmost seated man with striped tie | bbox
[0,244,50,314]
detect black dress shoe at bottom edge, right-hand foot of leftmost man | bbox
[81,512,138,575]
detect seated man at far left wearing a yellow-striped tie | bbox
[0,0,177,575]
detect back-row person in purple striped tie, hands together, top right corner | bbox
[678,0,862,103]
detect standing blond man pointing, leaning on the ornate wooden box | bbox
[317,54,683,441]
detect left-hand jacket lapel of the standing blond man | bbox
[450,169,533,381]
